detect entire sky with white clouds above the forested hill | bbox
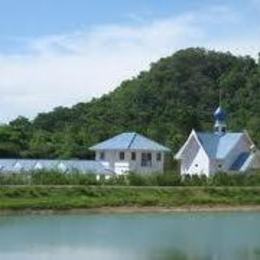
[0,0,260,122]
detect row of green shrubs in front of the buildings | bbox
[0,171,260,186]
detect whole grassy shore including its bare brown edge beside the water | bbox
[0,186,260,215]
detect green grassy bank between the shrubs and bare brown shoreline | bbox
[0,186,260,210]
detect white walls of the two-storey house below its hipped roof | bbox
[96,150,165,175]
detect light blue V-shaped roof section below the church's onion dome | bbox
[197,133,244,159]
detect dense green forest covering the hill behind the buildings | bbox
[0,48,260,158]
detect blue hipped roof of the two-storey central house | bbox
[90,133,170,152]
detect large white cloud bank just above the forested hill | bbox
[0,6,259,121]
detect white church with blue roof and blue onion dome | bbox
[175,106,260,176]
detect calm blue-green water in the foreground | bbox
[0,212,260,260]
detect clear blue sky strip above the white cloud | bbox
[0,0,260,52]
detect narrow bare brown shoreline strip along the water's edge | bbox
[0,205,260,216]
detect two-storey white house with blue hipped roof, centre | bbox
[90,133,170,174]
